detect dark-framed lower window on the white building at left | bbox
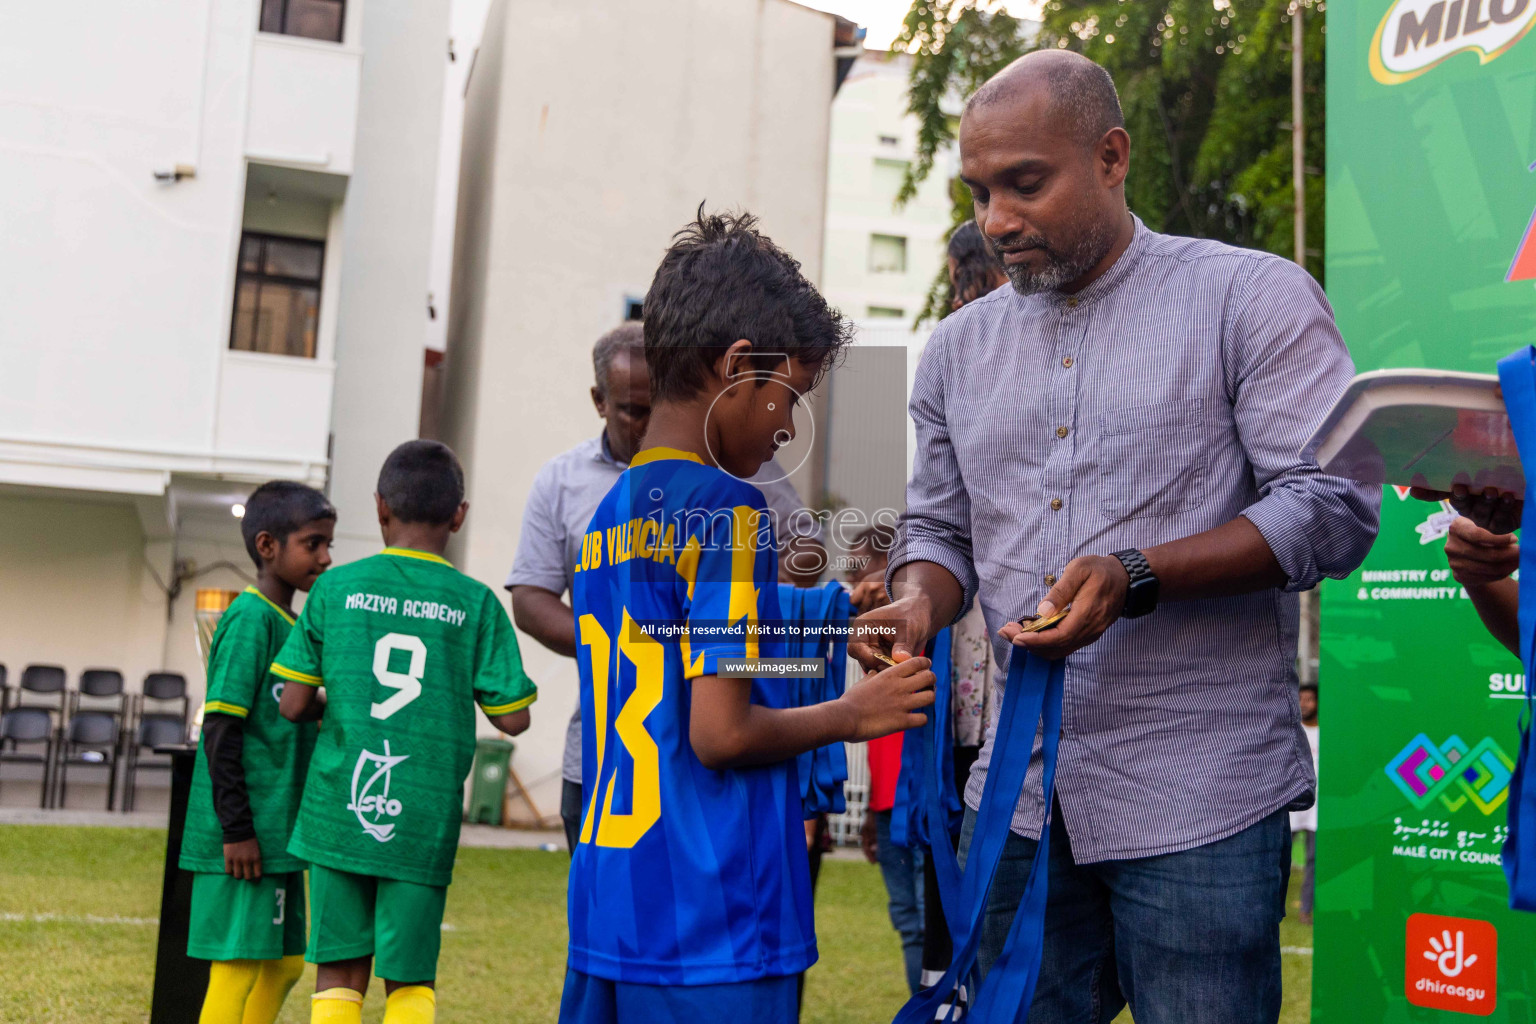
[229,232,326,359]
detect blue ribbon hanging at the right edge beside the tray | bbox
[1499,345,1536,910]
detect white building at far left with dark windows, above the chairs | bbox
[0,0,449,804]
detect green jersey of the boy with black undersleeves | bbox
[181,586,318,874]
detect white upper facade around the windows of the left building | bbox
[0,0,353,493]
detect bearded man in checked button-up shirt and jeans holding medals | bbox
[852,51,1379,1024]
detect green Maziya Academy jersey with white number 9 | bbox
[272,548,536,886]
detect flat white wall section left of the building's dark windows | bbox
[0,0,255,450]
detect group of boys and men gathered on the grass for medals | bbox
[174,51,1388,1024]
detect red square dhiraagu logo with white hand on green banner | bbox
[1404,913,1499,1016]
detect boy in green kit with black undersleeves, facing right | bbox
[180,481,336,1024]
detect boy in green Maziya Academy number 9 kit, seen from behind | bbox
[272,441,536,1024]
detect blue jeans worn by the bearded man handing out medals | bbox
[960,808,1290,1024]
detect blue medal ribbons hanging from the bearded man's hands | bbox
[895,648,1064,1024]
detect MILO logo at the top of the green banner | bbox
[1370,0,1536,86]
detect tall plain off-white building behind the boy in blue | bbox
[444,0,856,814]
